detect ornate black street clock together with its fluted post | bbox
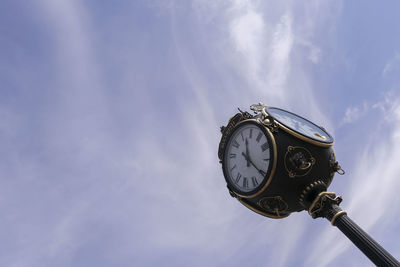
[218,103,400,266]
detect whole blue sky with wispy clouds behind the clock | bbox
[0,0,400,266]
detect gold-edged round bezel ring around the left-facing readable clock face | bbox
[222,119,277,198]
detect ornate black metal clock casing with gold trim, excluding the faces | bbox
[218,103,341,218]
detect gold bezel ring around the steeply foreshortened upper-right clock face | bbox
[265,107,334,147]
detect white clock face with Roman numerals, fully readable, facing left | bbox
[222,121,274,195]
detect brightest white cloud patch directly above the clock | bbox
[229,3,293,100]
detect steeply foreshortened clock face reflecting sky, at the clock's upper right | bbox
[267,108,333,144]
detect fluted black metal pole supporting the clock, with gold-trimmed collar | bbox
[308,192,400,267]
